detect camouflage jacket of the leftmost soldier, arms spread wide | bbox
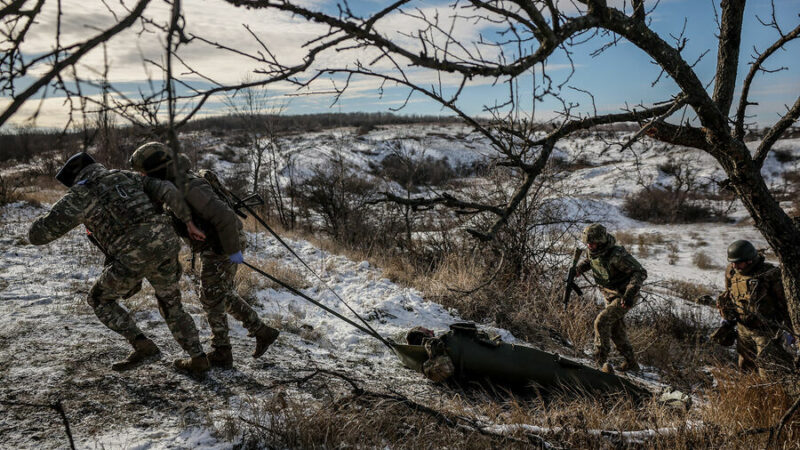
[28,164,191,256]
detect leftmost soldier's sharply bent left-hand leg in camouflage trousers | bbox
[87,264,143,343]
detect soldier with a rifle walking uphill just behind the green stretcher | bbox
[577,223,647,372]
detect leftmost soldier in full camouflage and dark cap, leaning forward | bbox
[29,153,209,374]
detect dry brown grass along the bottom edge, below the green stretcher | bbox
[218,369,800,449]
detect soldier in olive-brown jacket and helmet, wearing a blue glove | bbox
[130,142,279,368]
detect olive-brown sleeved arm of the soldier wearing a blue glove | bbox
[186,183,242,255]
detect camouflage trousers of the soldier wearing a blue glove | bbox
[200,246,266,347]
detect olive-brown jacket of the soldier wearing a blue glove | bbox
[170,172,243,255]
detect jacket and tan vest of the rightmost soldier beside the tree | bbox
[717,257,789,330]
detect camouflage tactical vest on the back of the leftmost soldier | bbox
[82,170,161,249]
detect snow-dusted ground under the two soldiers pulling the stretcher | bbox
[0,203,515,449]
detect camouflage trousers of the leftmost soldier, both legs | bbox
[87,237,203,356]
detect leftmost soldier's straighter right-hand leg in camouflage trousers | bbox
[147,255,203,357]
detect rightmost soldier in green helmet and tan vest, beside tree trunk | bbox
[717,240,792,377]
